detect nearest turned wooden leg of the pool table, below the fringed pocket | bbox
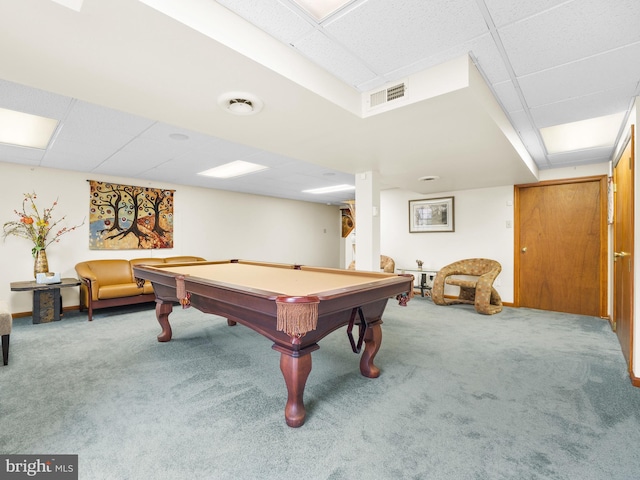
[280,352,311,427]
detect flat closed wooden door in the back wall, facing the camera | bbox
[515,176,607,316]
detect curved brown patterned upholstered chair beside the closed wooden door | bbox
[431,258,502,315]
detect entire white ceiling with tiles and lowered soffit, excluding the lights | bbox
[0,0,640,203]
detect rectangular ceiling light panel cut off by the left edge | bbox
[0,108,58,150]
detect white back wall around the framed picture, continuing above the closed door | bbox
[380,163,609,303]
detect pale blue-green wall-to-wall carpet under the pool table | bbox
[0,297,640,480]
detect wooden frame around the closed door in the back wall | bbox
[513,175,609,320]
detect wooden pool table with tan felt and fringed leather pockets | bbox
[133,260,413,427]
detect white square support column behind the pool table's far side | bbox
[355,171,380,272]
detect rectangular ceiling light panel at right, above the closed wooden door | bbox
[540,112,624,154]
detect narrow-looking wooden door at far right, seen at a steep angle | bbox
[612,129,635,368]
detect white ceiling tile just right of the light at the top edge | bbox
[325,0,488,74]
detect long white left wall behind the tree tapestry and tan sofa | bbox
[0,163,341,313]
